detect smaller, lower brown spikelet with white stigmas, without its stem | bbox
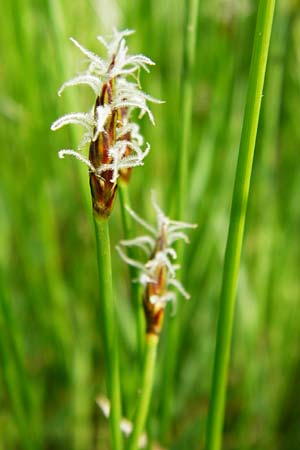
[117,198,197,335]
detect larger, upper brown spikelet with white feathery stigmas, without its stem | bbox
[51,30,162,218]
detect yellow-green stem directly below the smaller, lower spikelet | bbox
[128,334,158,450]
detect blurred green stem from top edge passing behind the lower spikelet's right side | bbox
[161,0,199,436]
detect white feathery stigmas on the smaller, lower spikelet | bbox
[117,197,197,306]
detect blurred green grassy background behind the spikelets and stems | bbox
[0,0,300,450]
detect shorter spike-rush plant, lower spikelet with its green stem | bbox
[117,198,196,450]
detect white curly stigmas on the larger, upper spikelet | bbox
[51,30,162,183]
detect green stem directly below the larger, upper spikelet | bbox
[94,218,123,450]
